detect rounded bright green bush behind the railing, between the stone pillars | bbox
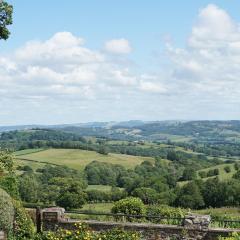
[111,197,146,222]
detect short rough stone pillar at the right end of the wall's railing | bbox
[183,213,211,230]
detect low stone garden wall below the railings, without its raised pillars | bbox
[43,220,240,240]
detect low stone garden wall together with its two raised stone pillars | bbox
[42,209,240,240]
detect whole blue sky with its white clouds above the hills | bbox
[0,0,240,125]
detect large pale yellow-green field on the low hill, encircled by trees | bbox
[15,149,154,170]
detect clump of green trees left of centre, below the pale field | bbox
[18,165,87,209]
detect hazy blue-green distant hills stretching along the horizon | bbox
[0,120,240,143]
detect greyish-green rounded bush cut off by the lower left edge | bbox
[0,188,14,232]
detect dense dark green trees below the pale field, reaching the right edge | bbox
[81,159,240,209]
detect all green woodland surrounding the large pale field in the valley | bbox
[0,129,240,208]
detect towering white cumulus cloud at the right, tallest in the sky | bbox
[167,4,240,105]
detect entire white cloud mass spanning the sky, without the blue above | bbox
[0,4,240,122]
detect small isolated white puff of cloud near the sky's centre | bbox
[105,38,132,54]
